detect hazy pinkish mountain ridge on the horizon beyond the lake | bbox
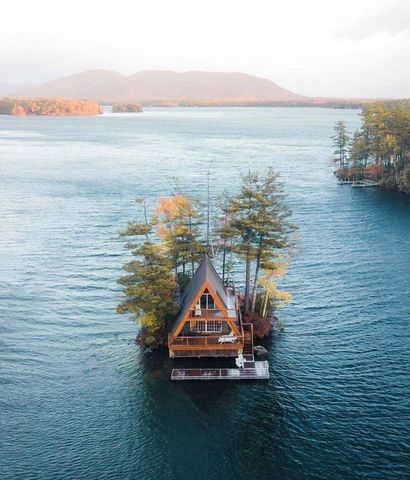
[13,69,308,102]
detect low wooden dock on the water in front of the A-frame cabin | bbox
[171,355,269,381]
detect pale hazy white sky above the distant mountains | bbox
[0,0,410,97]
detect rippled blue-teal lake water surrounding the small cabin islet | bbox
[0,108,410,480]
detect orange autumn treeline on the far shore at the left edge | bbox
[0,97,102,116]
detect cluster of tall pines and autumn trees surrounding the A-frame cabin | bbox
[117,170,295,346]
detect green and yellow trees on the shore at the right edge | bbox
[332,100,410,193]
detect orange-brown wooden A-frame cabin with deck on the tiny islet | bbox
[168,255,253,358]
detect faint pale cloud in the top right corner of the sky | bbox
[333,0,410,40]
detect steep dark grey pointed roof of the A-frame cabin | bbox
[174,255,229,329]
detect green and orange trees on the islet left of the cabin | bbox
[117,195,204,347]
